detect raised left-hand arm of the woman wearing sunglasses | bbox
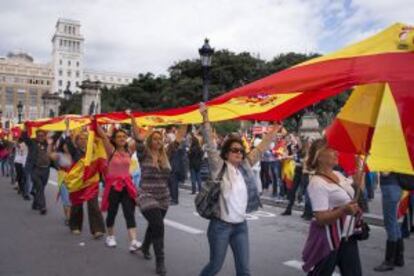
[200,103,224,176]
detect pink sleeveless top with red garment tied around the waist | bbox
[101,151,138,211]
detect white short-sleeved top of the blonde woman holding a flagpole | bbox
[308,171,355,212]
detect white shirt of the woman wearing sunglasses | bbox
[220,162,248,223]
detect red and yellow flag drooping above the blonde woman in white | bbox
[326,81,414,174]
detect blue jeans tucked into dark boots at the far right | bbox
[381,176,401,241]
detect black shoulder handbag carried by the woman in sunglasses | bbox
[194,163,227,219]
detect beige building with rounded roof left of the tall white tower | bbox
[0,52,53,123]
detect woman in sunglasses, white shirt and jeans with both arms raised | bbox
[200,104,282,276]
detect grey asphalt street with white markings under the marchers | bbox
[0,172,414,276]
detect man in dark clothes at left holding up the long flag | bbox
[22,130,50,215]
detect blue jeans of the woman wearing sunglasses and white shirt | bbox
[200,219,250,276]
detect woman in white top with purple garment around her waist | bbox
[303,139,362,276]
